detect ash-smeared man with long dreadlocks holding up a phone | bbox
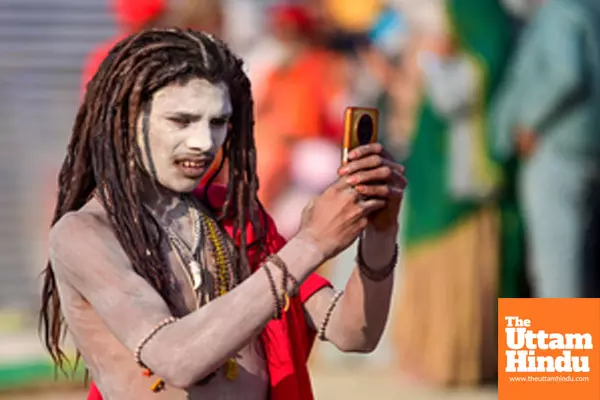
[40,29,406,400]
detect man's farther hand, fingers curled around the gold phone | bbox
[339,143,407,231]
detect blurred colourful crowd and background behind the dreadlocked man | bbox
[0,0,600,398]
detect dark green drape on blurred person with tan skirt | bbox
[404,0,524,297]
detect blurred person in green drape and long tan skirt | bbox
[396,0,523,386]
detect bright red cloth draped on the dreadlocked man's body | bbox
[88,185,331,400]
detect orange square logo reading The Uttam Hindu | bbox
[498,299,600,400]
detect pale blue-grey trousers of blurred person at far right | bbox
[521,152,586,298]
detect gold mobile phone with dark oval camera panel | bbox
[342,107,379,165]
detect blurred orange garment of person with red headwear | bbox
[255,49,343,207]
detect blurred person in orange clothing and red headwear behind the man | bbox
[255,3,347,212]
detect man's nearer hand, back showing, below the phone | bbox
[298,177,386,260]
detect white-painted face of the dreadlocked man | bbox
[137,78,232,193]
